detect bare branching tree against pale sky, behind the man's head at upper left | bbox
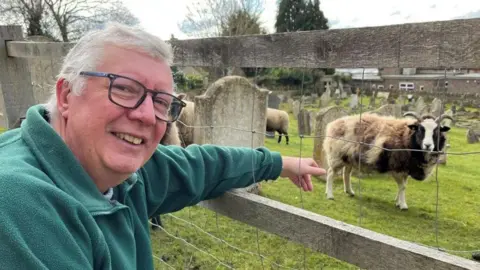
[0,0,139,42]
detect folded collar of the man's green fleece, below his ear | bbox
[21,105,137,214]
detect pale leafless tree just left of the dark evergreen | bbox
[179,0,264,37]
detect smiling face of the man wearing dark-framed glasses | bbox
[62,46,173,186]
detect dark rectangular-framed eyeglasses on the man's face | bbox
[80,71,187,123]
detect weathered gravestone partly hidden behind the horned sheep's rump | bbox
[313,106,348,180]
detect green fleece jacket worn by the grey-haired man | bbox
[0,105,282,270]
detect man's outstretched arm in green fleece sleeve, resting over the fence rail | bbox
[140,145,282,215]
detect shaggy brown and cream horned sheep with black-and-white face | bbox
[323,112,453,210]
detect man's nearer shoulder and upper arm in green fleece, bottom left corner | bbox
[0,173,109,270]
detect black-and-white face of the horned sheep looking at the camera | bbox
[410,119,450,152]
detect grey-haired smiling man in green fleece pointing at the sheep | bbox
[0,25,325,269]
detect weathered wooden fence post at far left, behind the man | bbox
[0,25,35,129]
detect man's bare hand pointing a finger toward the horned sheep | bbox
[280,157,326,191]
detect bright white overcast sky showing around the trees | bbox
[123,0,480,39]
